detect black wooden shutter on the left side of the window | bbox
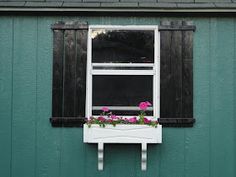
[50,22,88,127]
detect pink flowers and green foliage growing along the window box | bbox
[86,101,158,127]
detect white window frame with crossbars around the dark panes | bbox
[86,25,160,119]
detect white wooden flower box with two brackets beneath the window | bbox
[84,124,162,170]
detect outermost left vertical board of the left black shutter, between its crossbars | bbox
[52,30,64,117]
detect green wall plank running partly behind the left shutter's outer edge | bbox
[36,16,63,177]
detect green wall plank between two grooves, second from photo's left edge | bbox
[12,17,37,177]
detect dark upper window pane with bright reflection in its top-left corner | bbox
[92,29,154,63]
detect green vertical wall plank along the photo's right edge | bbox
[210,18,235,177]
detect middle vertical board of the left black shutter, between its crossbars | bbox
[63,30,76,117]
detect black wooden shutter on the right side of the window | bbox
[159,21,195,127]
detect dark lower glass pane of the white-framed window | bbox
[92,75,153,106]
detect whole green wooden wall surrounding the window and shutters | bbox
[0,16,236,177]
